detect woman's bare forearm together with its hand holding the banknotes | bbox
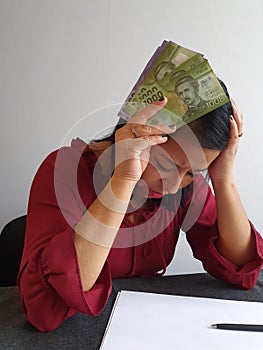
[74,99,175,291]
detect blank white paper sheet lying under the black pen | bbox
[100,291,263,350]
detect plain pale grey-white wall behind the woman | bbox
[0,0,263,273]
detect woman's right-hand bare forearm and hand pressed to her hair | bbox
[208,103,256,265]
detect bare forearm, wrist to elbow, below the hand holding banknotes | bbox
[74,175,134,291]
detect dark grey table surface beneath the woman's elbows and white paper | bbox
[0,272,263,350]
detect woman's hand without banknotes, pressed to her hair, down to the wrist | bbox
[208,100,243,183]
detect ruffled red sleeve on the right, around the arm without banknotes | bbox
[186,175,263,289]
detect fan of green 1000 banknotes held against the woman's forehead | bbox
[118,40,229,128]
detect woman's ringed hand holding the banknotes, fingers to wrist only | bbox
[114,98,176,183]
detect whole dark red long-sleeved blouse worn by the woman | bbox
[17,139,263,331]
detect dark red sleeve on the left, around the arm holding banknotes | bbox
[18,144,111,331]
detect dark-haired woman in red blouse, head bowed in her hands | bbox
[18,84,263,331]
